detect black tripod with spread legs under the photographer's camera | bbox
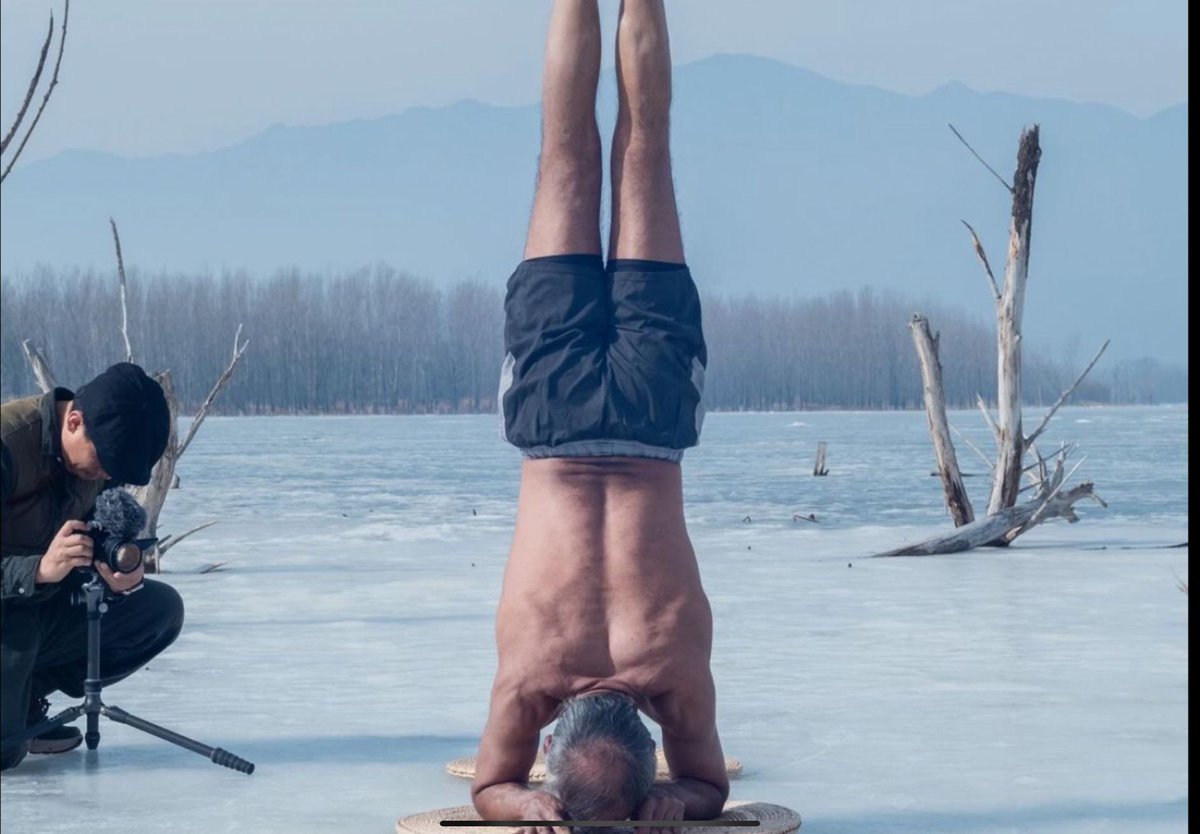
[2,571,254,774]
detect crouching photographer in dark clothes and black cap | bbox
[0,362,184,769]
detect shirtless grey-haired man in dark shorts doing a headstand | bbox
[472,0,728,834]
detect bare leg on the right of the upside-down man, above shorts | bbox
[608,0,684,264]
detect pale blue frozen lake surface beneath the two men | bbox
[0,407,1188,834]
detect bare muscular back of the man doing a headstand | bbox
[497,457,712,722]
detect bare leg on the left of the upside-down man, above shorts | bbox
[524,0,602,258]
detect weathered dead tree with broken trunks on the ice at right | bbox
[880,125,1109,556]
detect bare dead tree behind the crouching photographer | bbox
[23,218,250,574]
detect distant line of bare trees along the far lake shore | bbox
[0,265,1187,414]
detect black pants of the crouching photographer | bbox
[0,580,184,769]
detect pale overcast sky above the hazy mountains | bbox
[0,0,1188,162]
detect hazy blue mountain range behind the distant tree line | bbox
[0,55,1188,365]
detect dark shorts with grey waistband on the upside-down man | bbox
[499,256,708,461]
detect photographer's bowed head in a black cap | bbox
[61,362,170,486]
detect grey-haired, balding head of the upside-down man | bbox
[546,692,655,820]
